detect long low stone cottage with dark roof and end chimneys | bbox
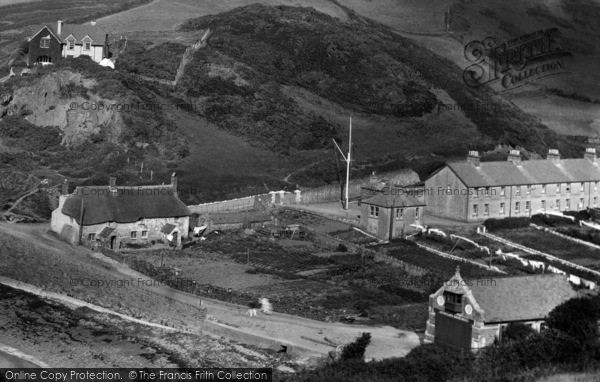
[50,174,190,249]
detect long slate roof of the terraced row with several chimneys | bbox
[446,158,600,187]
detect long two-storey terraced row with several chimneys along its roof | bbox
[425,148,600,222]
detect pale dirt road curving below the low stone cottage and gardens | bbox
[0,223,419,359]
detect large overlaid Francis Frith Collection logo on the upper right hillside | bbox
[463,28,572,91]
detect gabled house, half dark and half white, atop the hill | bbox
[27,21,108,66]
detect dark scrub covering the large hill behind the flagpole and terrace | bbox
[182,4,579,156]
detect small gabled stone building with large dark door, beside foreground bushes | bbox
[425,268,578,349]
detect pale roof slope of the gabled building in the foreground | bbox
[468,274,578,323]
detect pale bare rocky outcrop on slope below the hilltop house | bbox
[0,71,124,146]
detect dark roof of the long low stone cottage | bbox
[62,185,190,225]
